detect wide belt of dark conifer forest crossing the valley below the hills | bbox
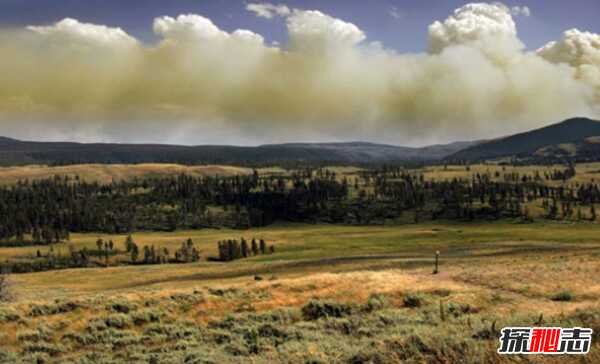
[0,167,600,246]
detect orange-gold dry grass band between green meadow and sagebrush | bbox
[3,247,600,318]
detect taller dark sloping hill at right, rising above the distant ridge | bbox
[445,118,600,162]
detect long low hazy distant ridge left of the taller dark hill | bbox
[0,137,476,166]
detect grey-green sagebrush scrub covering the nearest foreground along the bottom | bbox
[0,288,600,364]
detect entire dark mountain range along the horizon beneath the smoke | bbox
[0,118,600,166]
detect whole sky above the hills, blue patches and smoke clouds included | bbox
[0,0,600,146]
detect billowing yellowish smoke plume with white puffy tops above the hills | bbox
[0,3,600,144]
